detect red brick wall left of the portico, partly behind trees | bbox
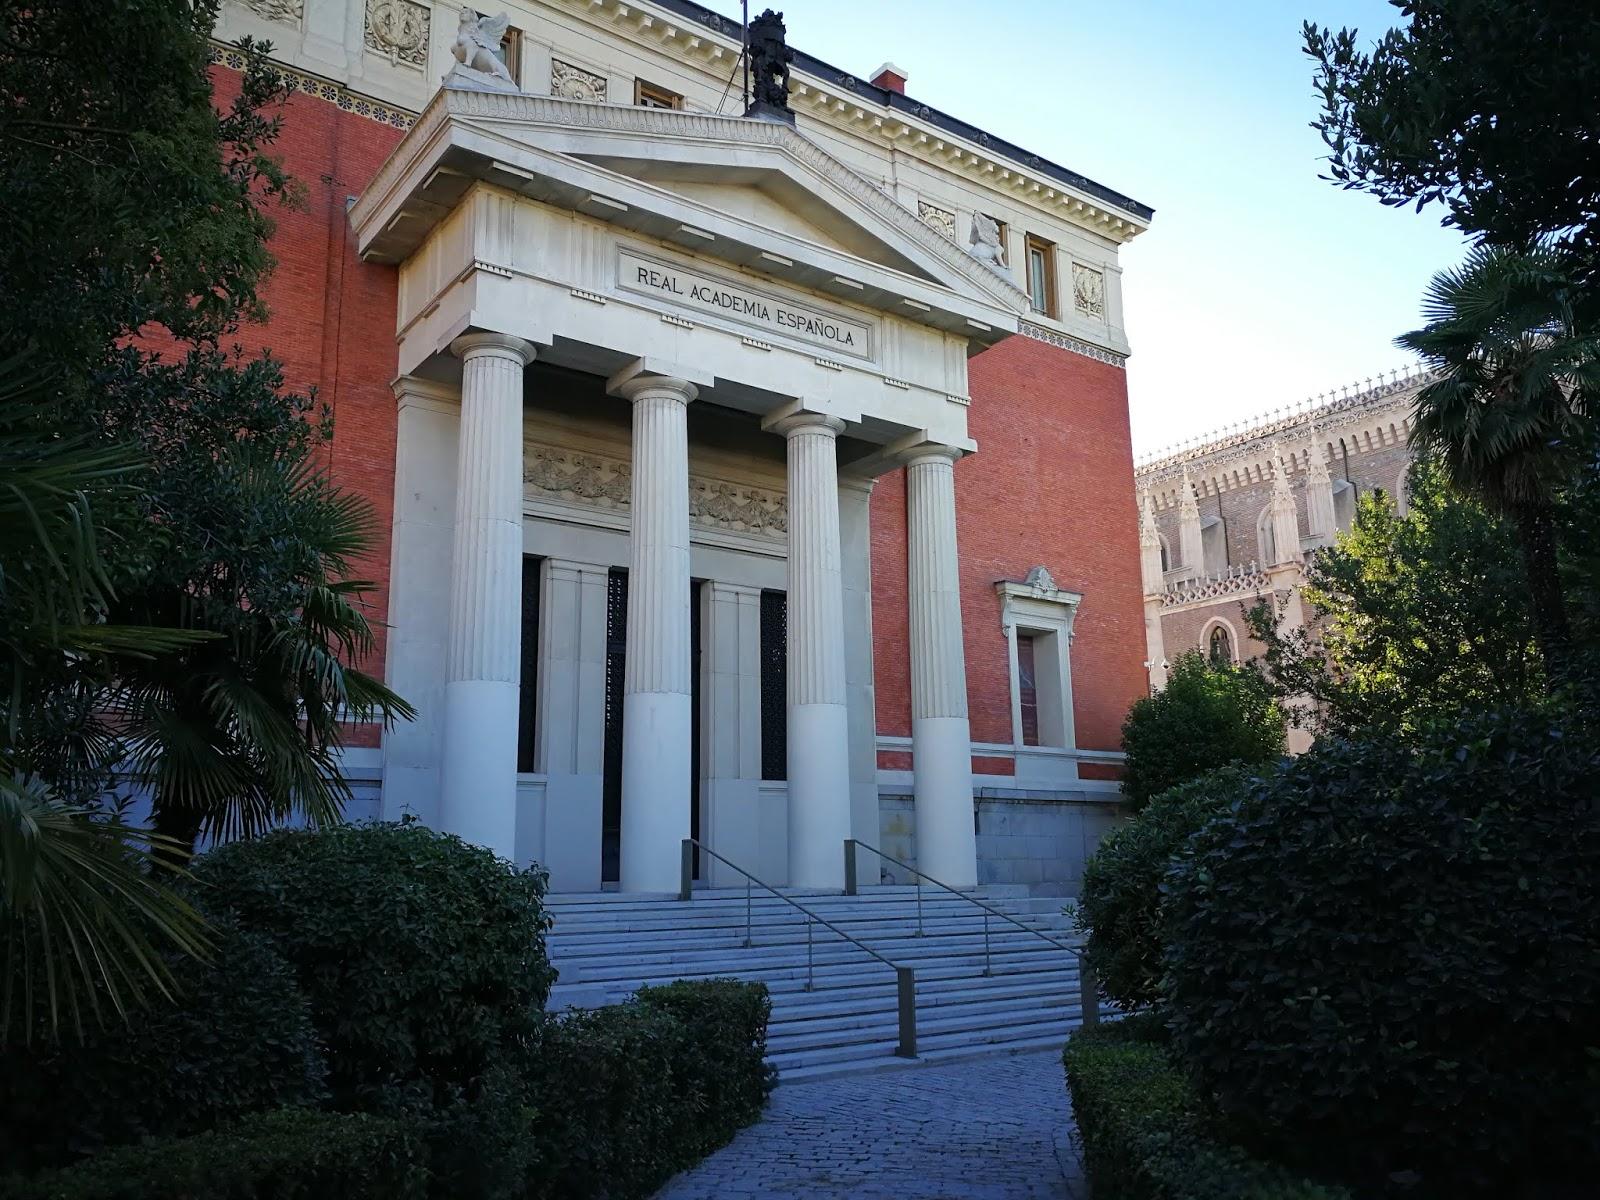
[211,67,405,746]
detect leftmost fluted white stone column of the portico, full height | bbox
[438,333,534,858]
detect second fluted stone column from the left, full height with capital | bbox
[613,374,698,891]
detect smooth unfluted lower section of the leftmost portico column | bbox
[438,680,520,866]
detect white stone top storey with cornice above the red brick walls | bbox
[218,0,1150,365]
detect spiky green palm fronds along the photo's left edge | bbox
[0,363,206,1040]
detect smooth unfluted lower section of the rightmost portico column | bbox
[910,717,978,888]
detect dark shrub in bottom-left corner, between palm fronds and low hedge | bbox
[0,918,325,1168]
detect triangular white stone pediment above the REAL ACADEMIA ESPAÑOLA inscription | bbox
[350,88,1029,344]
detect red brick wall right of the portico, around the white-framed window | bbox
[872,336,1146,768]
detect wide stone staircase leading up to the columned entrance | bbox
[549,885,1080,1080]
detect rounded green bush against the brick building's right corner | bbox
[1122,651,1285,811]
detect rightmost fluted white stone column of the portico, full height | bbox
[906,446,978,888]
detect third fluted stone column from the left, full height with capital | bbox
[771,411,850,888]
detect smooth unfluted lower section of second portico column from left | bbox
[618,691,691,893]
